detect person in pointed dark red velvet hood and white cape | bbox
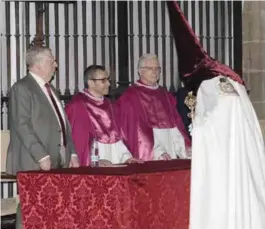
[168,2,265,229]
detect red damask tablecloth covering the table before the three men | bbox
[18,160,190,229]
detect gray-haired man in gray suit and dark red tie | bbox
[6,47,79,229]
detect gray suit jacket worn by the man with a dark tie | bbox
[6,74,76,175]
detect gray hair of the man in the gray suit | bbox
[26,46,51,67]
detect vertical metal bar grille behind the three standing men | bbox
[0,0,242,129]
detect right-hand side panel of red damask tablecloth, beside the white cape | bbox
[130,170,190,229]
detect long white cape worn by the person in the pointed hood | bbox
[190,76,265,229]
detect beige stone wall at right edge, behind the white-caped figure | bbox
[241,1,265,136]
